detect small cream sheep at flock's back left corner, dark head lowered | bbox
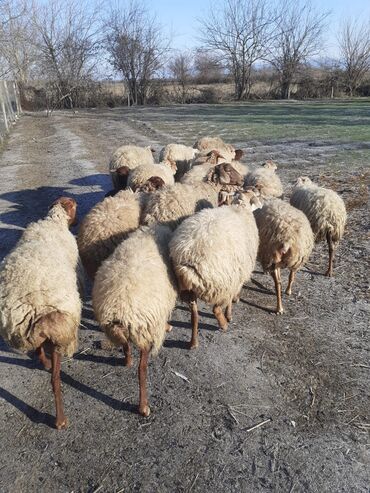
[109,144,155,189]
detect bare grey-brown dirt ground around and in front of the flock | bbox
[0,111,370,493]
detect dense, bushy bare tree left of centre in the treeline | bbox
[106,0,169,105]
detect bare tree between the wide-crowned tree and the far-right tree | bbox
[267,0,329,99]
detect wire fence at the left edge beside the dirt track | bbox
[0,80,22,144]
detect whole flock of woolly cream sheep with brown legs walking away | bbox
[0,137,346,429]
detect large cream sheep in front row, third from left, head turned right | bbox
[170,191,262,349]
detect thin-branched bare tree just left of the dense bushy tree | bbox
[33,0,100,108]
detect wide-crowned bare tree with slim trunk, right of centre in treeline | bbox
[200,0,274,100]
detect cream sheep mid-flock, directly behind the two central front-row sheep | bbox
[142,164,241,229]
